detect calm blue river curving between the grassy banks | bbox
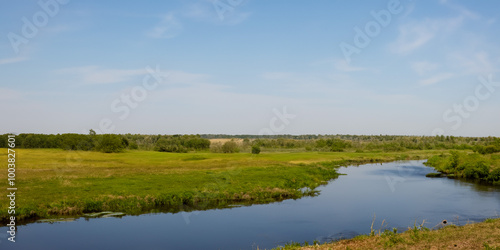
[0,161,500,249]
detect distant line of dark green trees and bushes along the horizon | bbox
[0,134,500,154]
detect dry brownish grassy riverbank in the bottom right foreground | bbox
[276,219,500,250]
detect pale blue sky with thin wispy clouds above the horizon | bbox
[0,0,500,136]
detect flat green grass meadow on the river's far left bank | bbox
[0,149,450,221]
